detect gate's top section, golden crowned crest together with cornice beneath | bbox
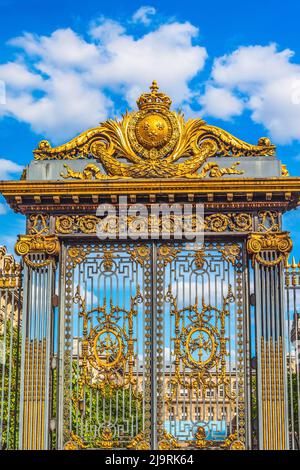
[0,82,300,216]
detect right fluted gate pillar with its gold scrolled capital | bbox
[247,232,292,450]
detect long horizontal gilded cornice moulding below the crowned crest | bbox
[0,177,300,197]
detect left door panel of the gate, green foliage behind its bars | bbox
[58,243,152,449]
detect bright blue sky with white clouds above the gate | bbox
[0,0,300,258]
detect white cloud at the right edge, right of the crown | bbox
[202,44,300,143]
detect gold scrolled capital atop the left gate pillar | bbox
[15,234,60,269]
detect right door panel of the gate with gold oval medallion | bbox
[157,242,248,449]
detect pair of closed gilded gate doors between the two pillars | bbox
[58,240,249,449]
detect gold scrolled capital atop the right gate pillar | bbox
[247,232,293,267]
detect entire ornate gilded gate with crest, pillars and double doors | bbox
[0,82,300,450]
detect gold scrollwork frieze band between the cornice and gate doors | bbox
[18,210,281,239]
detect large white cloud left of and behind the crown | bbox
[0,17,207,143]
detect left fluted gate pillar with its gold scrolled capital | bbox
[15,234,60,450]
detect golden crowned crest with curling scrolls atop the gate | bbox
[34,82,275,180]
